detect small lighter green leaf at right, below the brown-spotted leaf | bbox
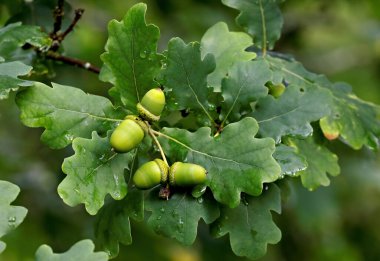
[287,137,340,190]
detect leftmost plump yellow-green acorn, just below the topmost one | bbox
[110,118,145,153]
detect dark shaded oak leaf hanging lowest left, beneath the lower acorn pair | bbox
[95,186,144,258]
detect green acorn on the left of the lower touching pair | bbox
[133,159,169,189]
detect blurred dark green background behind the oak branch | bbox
[0,0,380,261]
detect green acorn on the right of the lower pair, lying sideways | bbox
[169,162,207,187]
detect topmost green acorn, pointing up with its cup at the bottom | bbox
[137,88,165,121]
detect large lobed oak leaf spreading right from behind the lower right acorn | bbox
[160,117,281,207]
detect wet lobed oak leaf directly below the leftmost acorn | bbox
[58,132,133,215]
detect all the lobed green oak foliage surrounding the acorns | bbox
[0,0,380,260]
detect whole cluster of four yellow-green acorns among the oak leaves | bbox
[110,88,207,192]
